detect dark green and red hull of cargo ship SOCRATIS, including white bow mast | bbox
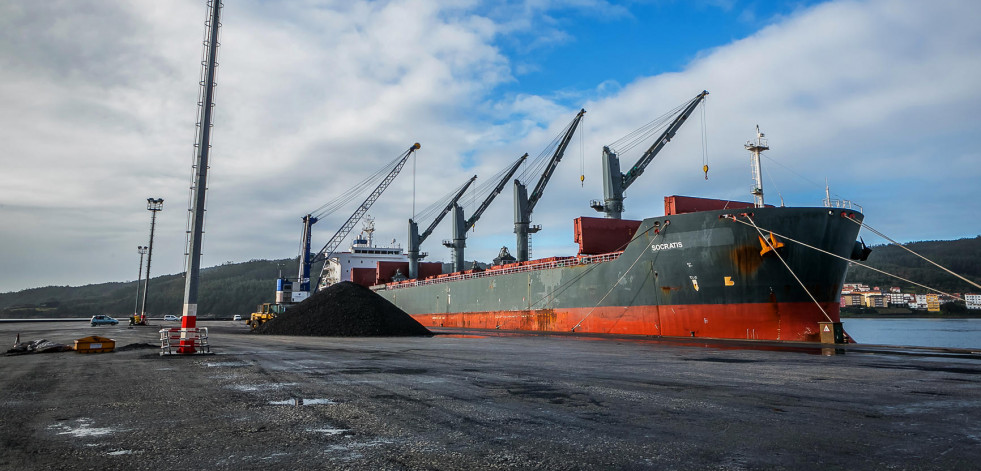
[372,130,868,343]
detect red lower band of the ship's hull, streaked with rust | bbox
[412,303,840,342]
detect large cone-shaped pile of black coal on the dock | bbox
[253,281,432,337]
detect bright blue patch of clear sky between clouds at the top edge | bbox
[497,1,817,98]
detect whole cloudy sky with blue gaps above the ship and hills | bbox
[0,0,981,292]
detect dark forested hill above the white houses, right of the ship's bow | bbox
[846,236,981,293]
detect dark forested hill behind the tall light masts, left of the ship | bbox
[0,259,296,319]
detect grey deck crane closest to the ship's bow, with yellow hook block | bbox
[589,90,708,219]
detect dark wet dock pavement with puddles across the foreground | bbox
[0,321,981,470]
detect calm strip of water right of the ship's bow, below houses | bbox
[842,318,981,349]
